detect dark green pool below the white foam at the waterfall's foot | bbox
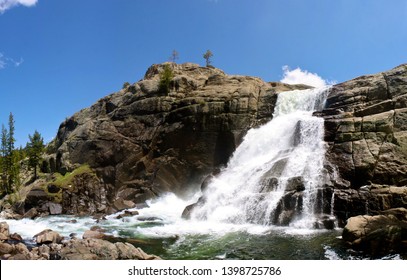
[155,230,348,260]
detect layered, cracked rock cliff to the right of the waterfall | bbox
[321,65,407,224]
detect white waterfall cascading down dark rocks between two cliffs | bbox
[191,88,328,227]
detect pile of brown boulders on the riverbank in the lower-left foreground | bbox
[0,222,160,260]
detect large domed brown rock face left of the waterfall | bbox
[49,64,306,214]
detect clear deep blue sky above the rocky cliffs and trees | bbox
[0,0,407,145]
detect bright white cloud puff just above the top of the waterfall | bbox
[280,65,335,87]
